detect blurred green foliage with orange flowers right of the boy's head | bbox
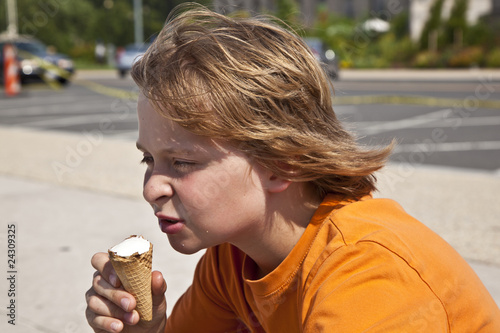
[308,0,500,68]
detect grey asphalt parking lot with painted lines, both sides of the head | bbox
[0,71,500,172]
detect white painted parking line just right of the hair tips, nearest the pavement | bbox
[394,141,500,153]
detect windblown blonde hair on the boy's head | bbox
[132,5,391,199]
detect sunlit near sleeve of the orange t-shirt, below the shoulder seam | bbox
[303,241,449,333]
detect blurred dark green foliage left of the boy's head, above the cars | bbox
[0,0,206,60]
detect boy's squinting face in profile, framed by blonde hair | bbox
[137,95,270,253]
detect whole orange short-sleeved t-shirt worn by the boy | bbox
[165,195,500,333]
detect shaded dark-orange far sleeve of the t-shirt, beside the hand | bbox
[165,248,241,333]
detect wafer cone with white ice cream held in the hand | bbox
[108,236,153,323]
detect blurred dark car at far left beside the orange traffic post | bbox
[0,35,75,84]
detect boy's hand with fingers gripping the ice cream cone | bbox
[85,252,167,333]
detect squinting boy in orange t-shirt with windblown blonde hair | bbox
[86,3,500,332]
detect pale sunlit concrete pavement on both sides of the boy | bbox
[0,71,500,332]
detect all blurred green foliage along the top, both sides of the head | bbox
[0,0,500,68]
